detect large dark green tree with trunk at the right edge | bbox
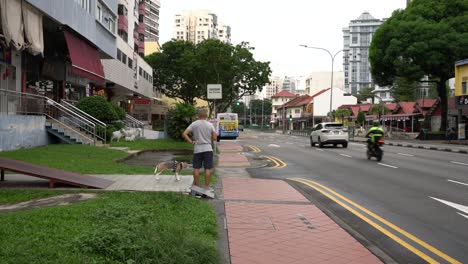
[369,0,468,130]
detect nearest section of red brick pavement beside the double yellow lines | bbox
[222,177,381,264]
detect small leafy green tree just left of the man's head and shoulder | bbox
[166,103,197,141]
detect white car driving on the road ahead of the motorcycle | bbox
[310,122,349,148]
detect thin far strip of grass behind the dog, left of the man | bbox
[111,138,193,150]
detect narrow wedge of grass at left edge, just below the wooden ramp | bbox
[0,189,74,204]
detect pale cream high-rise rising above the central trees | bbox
[173,10,231,44]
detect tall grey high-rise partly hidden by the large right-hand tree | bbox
[343,12,384,94]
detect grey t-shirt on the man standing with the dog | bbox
[187,120,216,153]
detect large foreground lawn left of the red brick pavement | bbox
[0,192,218,264]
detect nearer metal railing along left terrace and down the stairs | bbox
[0,89,97,144]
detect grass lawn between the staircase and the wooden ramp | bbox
[0,144,154,174]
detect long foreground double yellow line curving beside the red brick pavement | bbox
[289,178,461,264]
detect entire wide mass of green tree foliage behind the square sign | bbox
[145,39,271,112]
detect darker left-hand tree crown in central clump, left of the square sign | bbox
[145,40,199,105]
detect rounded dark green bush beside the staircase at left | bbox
[76,96,119,123]
